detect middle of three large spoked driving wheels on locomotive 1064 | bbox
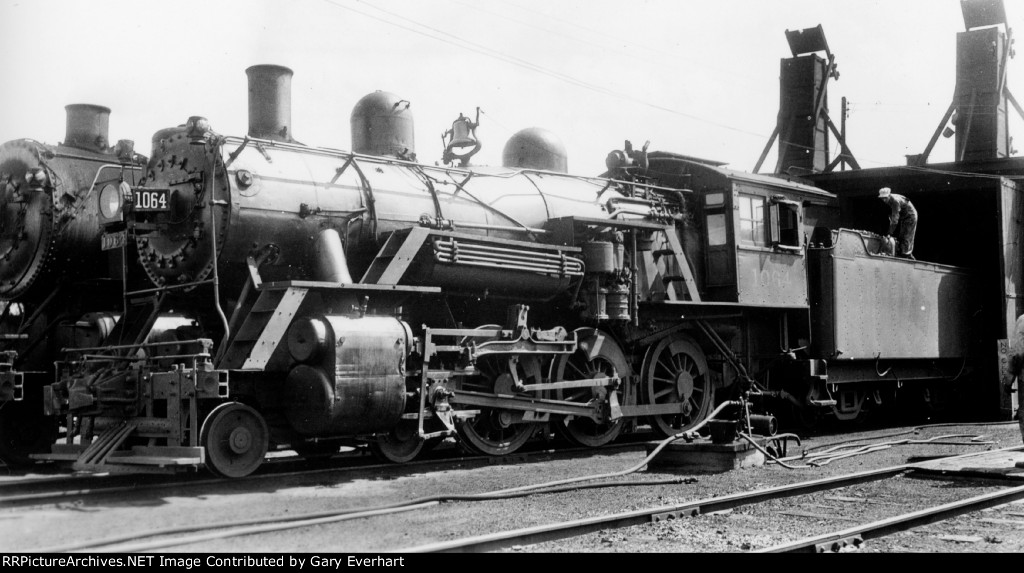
[551,328,632,447]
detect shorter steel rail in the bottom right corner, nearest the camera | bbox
[751,485,1024,554]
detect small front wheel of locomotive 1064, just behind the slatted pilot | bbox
[200,402,269,478]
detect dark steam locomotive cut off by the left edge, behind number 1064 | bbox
[0,104,145,462]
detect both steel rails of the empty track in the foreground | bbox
[398,446,1024,553]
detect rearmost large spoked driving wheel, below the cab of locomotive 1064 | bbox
[643,335,714,437]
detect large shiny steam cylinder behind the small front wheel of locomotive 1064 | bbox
[283,316,412,437]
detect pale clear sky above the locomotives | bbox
[0,0,1024,175]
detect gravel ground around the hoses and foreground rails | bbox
[0,424,1024,554]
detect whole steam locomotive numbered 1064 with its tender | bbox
[8,65,983,477]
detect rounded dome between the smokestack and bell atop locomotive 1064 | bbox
[351,91,416,160]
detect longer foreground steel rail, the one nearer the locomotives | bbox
[400,446,1024,553]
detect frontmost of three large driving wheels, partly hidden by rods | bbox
[456,359,542,455]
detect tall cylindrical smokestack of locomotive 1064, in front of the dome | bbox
[246,64,295,142]
